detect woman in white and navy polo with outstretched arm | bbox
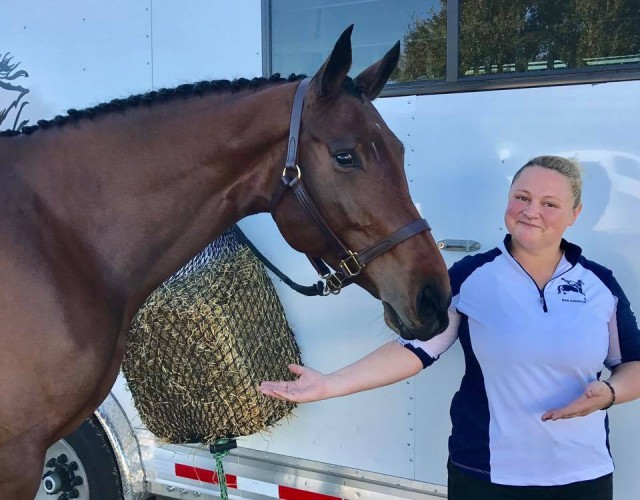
[261,156,640,500]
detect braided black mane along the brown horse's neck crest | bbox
[0,73,362,137]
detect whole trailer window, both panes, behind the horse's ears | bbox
[263,0,640,95]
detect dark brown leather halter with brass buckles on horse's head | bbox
[271,77,431,295]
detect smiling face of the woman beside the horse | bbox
[504,166,582,252]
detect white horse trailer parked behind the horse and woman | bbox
[0,0,640,500]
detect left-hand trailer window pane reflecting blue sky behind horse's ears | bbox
[265,0,446,80]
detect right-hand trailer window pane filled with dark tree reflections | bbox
[459,0,640,77]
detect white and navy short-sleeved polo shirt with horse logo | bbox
[402,235,640,486]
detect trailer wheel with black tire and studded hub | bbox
[35,417,122,500]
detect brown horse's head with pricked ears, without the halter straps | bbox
[272,26,451,340]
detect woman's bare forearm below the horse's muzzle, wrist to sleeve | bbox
[325,341,422,397]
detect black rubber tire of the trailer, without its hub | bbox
[36,417,123,500]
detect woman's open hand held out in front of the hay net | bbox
[258,365,330,403]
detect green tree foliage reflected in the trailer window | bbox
[393,0,640,81]
